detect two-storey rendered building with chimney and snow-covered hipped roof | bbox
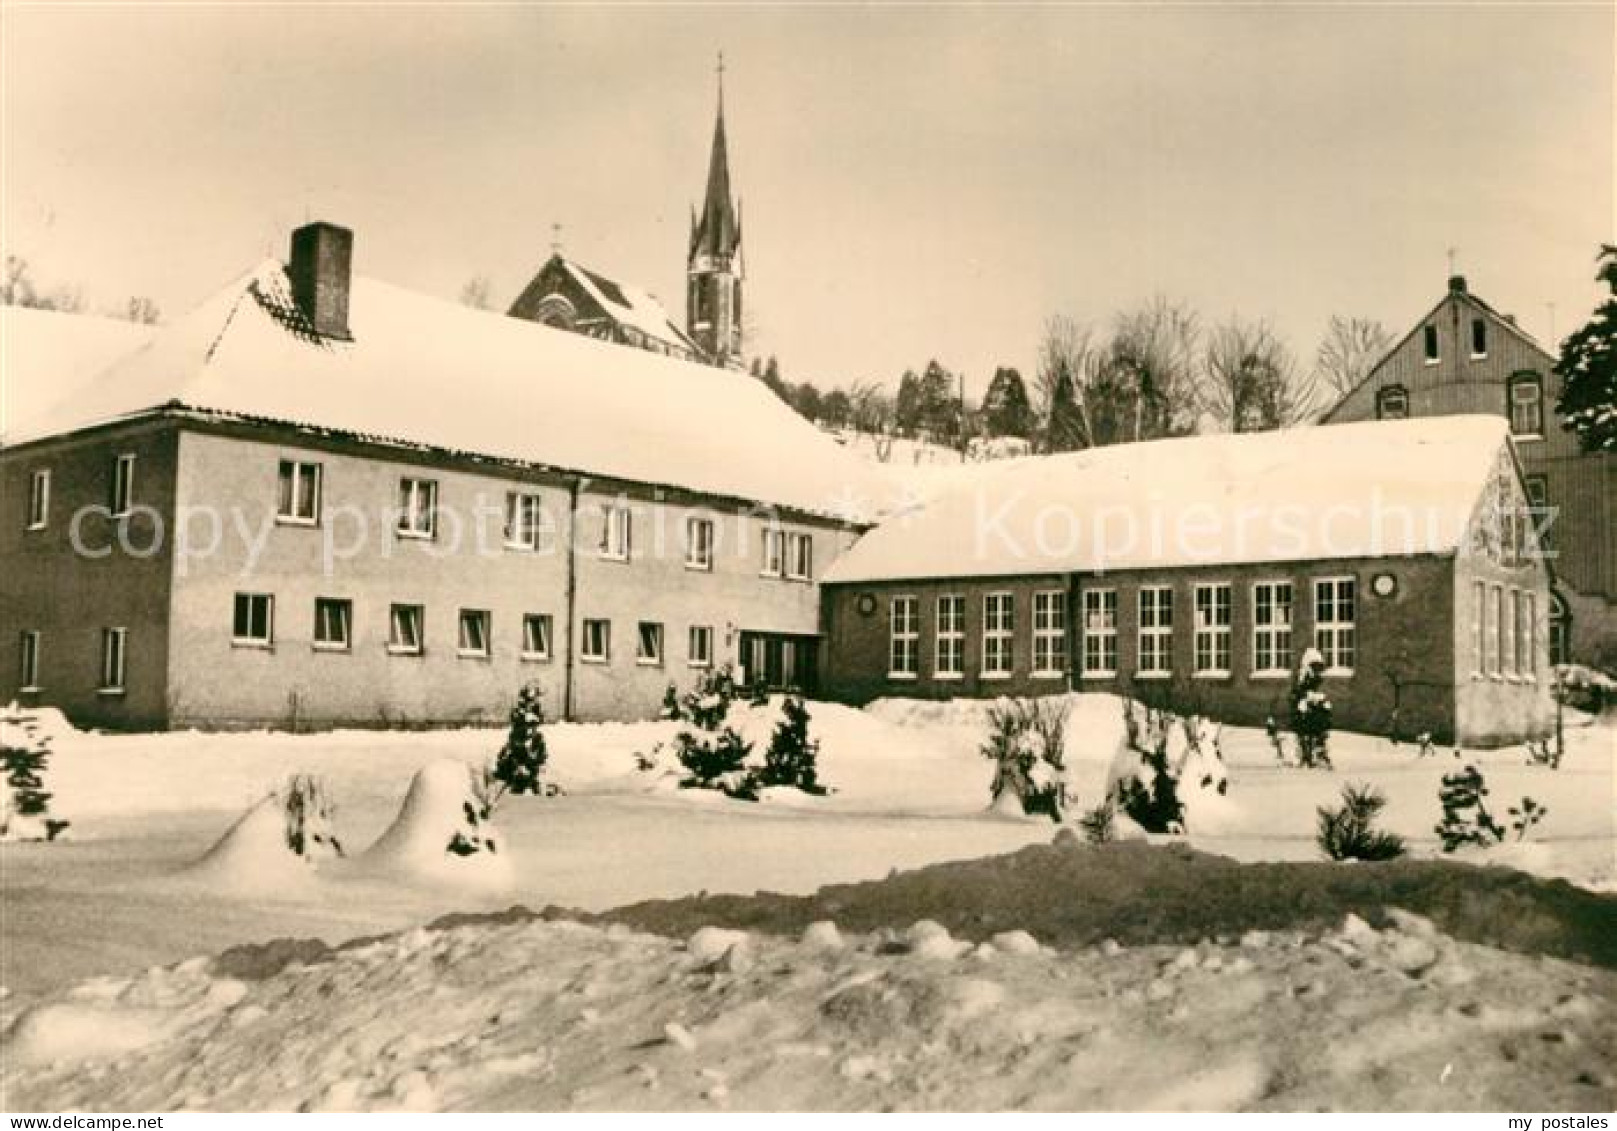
[0,223,881,726]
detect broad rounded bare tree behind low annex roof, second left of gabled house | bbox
[1200,316,1323,432]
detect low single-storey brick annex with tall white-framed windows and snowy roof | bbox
[821,416,1551,744]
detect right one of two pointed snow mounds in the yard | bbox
[357,759,514,888]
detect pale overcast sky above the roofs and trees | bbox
[0,3,1614,398]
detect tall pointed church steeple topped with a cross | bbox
[686,52,742,366]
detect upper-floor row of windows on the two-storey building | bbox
[26,453,813,581]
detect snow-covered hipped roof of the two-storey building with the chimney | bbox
[3,261,883,516]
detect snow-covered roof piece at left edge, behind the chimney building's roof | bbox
[0,306,157,440]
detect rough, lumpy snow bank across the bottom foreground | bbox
[0,913,1617,1112]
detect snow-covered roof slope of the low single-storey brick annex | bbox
[825,416,1509,582]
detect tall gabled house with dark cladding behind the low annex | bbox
[1323,275,1617,668]
